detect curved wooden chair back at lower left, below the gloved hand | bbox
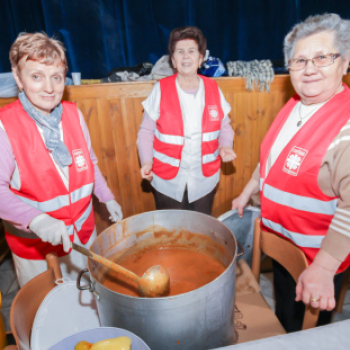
[9,254,62,350]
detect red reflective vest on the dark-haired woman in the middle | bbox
[153,74,224,180]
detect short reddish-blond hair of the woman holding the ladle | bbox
[10,33,68,74]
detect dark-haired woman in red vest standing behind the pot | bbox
[137,27,236,215]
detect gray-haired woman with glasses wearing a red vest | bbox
[232,14,350,332]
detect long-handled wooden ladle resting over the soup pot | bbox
[71,242,170,297]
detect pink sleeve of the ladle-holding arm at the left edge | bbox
[0,128,42,232]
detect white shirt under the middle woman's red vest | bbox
[142,79,231,203]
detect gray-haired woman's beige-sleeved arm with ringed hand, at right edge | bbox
[296,123,350,310]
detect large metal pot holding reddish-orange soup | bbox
[78,210,237,350]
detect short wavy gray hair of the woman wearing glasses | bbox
[283,13,350,66]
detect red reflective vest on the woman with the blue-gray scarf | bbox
[0,100,95,260]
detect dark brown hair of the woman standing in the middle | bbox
[168,26,207,67]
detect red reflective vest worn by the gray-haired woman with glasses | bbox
[260,85,350,272]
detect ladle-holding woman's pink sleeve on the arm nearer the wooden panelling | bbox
[79,110,114,203]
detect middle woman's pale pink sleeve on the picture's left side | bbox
[137,112,156,166]
